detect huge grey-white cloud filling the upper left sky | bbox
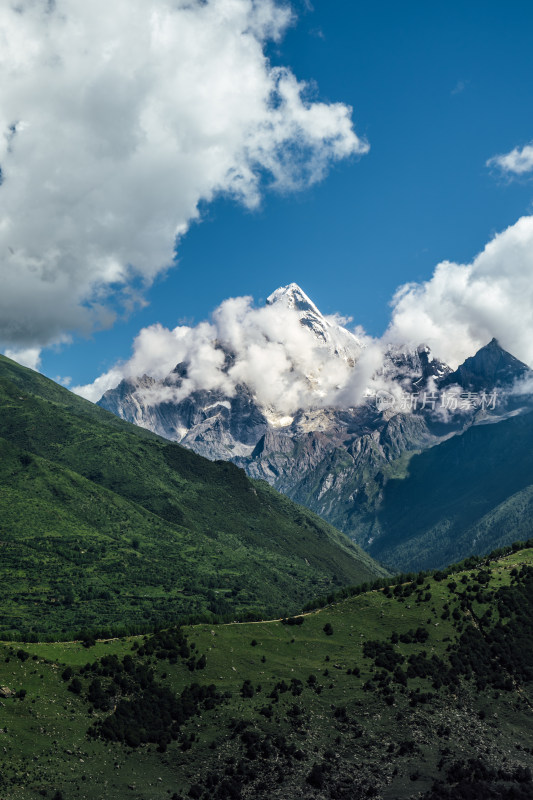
[0,0,368,354]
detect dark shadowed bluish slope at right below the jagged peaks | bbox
[369,413,533,569]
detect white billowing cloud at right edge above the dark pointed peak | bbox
[385,216,533,366]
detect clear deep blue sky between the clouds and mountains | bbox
[3,0,533,384]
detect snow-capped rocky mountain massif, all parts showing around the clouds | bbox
[95,284,530,547]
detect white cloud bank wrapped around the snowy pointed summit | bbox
[74,290,366,414]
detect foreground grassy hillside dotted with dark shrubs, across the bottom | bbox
[0,543,533,800]
